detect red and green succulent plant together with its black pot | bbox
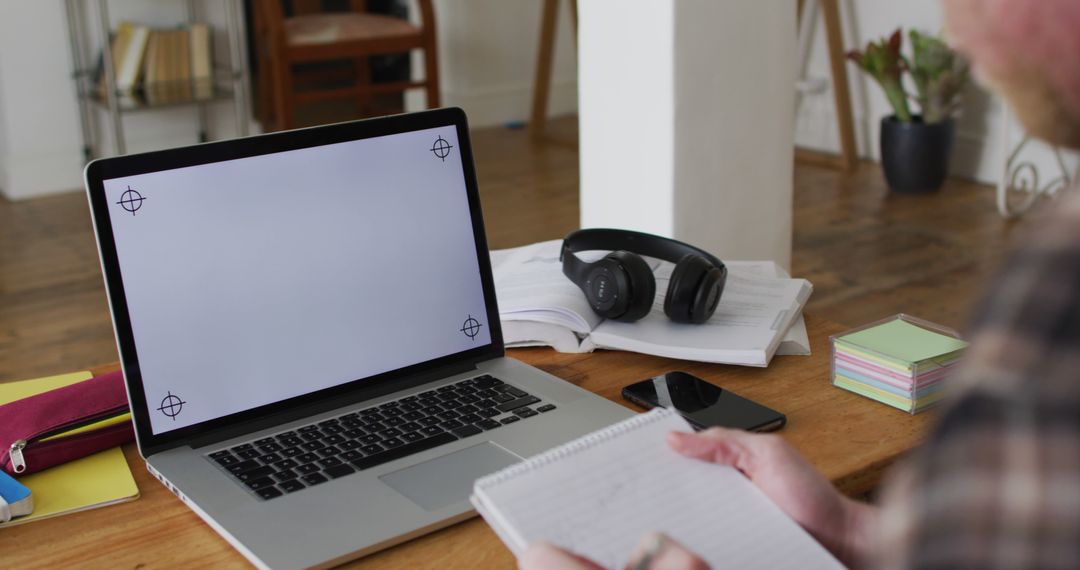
[848,28,969,193]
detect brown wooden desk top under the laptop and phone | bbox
[0,315,931,568]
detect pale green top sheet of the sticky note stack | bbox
[837,318,968,363]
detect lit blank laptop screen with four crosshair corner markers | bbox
[98,125,492,434]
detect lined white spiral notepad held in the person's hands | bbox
[471,409,843,569]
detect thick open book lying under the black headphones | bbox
[491,240,813,366]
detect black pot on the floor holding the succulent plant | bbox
[881,116,954,194]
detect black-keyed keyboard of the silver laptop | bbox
[208,375,555,500]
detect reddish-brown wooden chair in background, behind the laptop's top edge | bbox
[253,0,440,131]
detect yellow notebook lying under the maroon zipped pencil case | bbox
[0,372,138,528]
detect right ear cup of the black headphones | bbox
[664,254,727,323]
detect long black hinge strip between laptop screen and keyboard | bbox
[181,362,476,452]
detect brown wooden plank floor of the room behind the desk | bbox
[0,119,1023,380]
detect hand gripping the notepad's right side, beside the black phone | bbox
[667,428,877,565]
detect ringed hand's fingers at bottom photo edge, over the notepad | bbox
[518,534,708,570]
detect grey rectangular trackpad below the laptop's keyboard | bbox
[379,442,522,511]
